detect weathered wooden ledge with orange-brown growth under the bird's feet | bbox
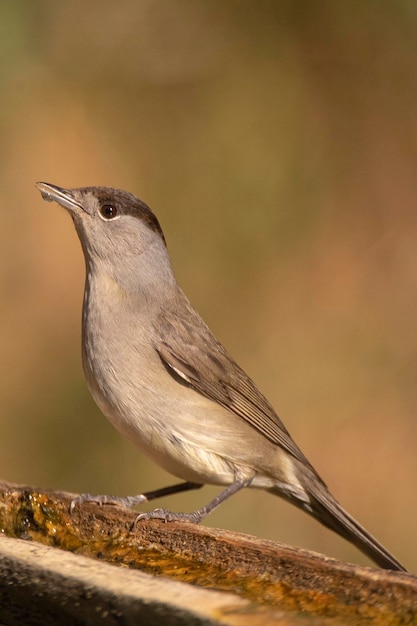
[0,482,417,626]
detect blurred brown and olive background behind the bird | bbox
[0,0,417,571]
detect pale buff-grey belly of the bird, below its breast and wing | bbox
[83,312,277,488]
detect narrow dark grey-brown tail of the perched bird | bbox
[271,468,407,572]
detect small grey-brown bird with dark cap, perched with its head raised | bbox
[36,182,406,571]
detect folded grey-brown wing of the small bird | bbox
[155,302,314,471]
